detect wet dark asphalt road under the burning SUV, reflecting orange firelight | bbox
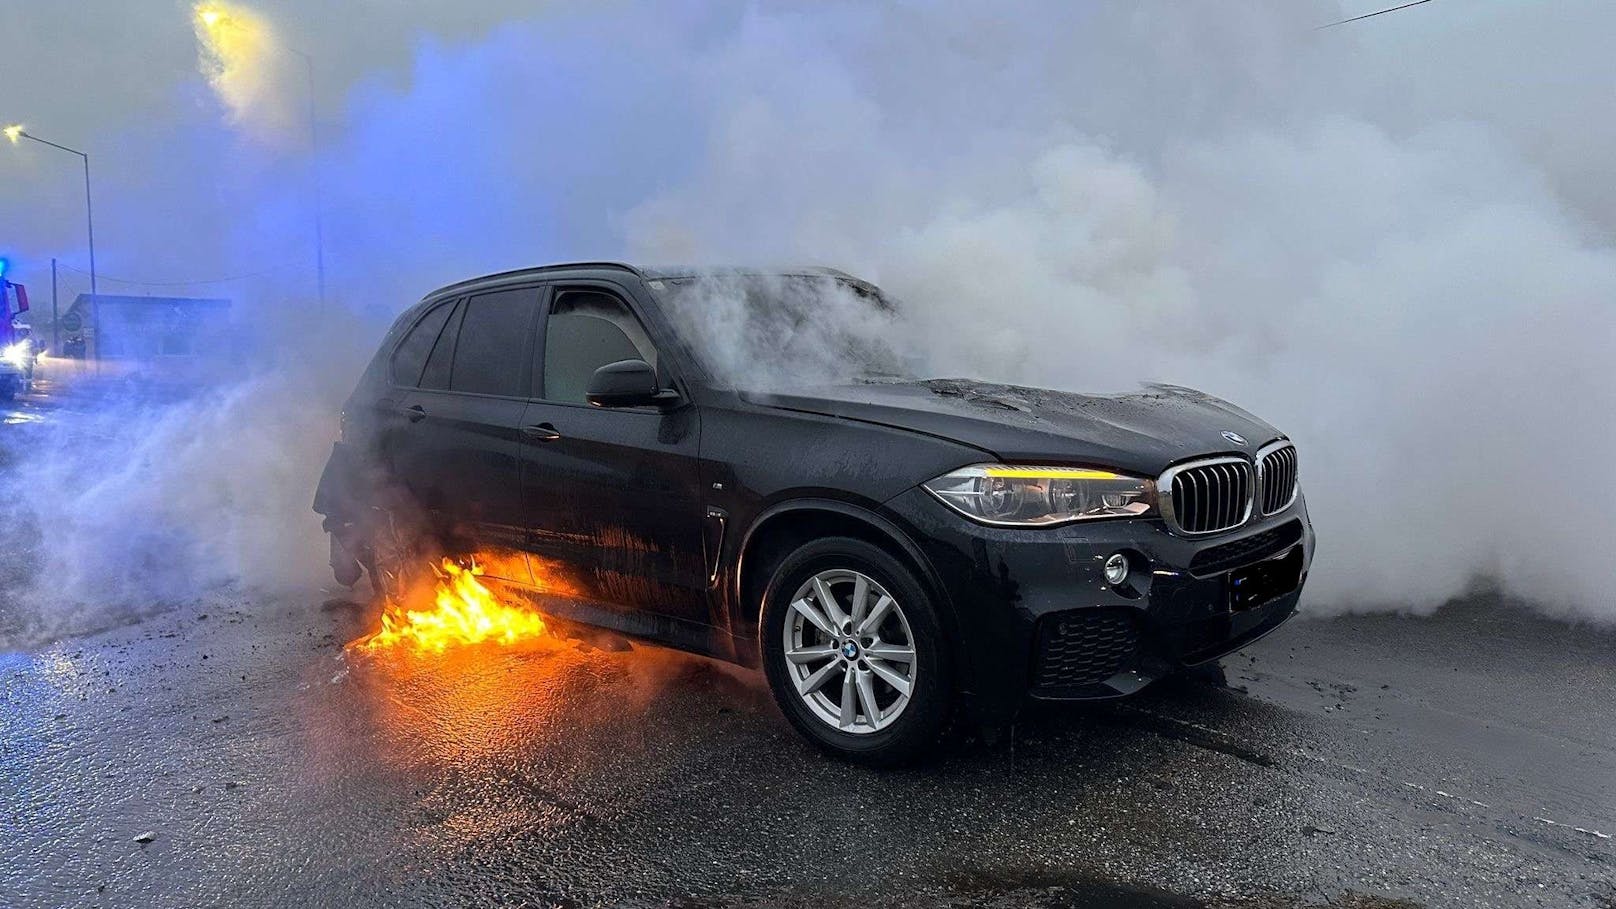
[0,582,1616,906]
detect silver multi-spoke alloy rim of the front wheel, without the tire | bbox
[782,568,918,734]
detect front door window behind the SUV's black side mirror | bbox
[543,291,656,404]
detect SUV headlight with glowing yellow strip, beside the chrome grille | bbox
[923,464,1155,527]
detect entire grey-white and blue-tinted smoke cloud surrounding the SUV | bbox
[0,0,1616,640]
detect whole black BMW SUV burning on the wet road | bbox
[315,262,1314,762]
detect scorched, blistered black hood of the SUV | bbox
[742,378,1280,476]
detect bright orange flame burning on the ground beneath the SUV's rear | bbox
[347,558,545,653]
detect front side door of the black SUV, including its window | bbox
[520,281,711,634]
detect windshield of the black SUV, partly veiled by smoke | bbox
[650,265,915,390]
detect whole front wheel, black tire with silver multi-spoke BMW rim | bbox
[758,537,953,767]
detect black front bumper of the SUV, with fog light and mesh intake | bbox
[886,488,1314,708]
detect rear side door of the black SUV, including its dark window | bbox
[393,286,541,581]
